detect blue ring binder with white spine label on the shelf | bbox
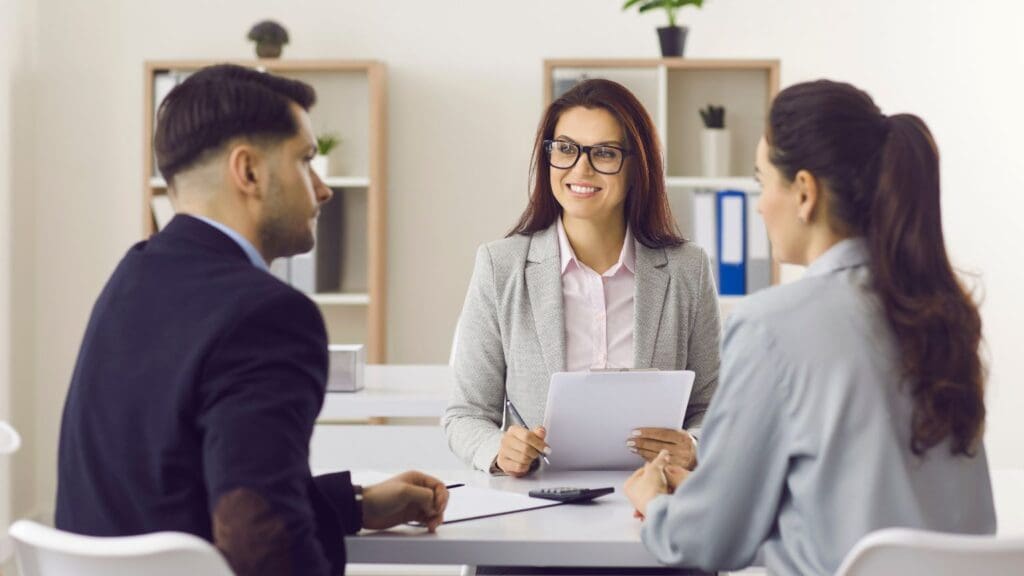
[716,190,746,296]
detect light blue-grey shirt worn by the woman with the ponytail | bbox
[641,239,995,575]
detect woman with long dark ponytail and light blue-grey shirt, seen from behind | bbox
[626,81,995,574]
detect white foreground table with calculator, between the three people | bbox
[346,469,700,568]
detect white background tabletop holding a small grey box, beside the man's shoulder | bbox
[317,364,455,423]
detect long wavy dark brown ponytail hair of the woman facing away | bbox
[766,80,985,455]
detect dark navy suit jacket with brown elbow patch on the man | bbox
[56,215,360,575]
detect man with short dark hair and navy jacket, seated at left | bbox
[56,65,447,575]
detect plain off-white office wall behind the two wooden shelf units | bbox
[14,0,1024,516]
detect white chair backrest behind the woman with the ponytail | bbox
[836,528,1024,576]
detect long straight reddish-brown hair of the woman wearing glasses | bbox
[508,79,684,248]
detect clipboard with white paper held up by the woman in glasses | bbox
[544,370,695,470]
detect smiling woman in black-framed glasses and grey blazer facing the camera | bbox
[442,80,721,477]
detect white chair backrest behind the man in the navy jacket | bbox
[10,520,231,576]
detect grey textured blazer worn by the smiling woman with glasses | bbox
[441,225,721,470]
